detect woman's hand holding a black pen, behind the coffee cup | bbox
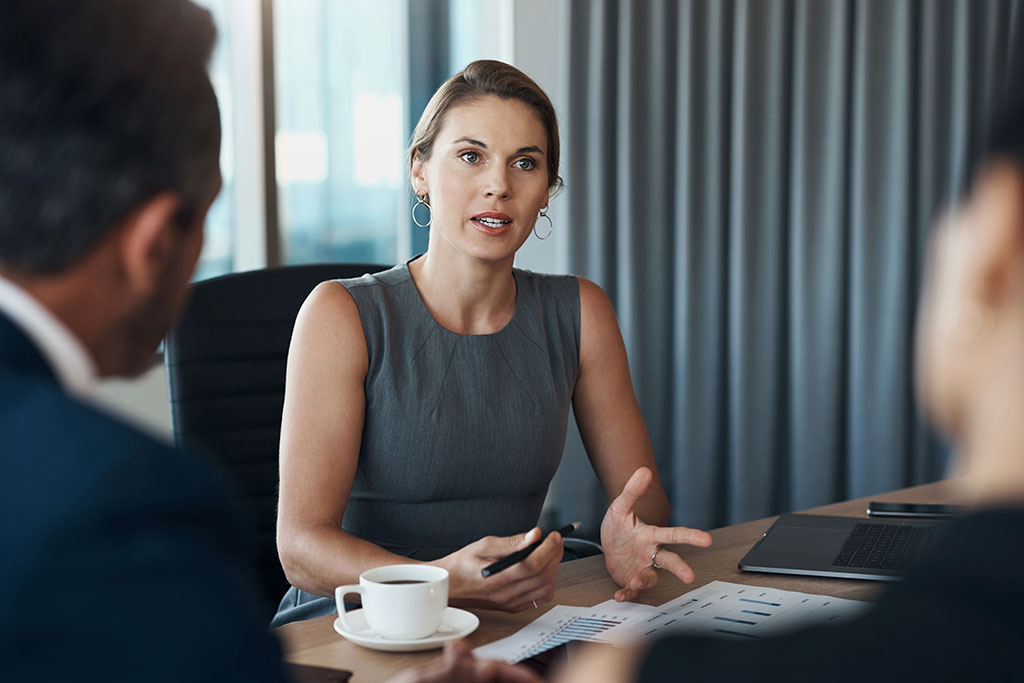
[431,526,562,612]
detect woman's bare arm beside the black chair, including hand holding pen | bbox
[278,283,562,610]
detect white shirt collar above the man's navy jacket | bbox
[0,278,97,398]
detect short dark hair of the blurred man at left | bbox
[0,0,220,274]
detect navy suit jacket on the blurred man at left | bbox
[0,315,284,683]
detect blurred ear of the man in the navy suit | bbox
[118,193,180,296]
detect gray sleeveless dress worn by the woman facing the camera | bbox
[272,264,580,626]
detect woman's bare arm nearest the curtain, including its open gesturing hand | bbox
[572,278,711,600]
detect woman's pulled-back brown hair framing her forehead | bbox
[408,59,563,191]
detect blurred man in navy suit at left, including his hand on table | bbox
[0,0,534,682]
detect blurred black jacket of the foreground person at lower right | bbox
[640,509,1024,683]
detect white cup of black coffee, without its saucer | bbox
[334,564,447,640]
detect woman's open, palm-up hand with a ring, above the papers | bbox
[601,467,711,602]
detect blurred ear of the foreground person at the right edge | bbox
[969,161,1024,311]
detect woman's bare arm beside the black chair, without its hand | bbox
[278,282,409,596]
